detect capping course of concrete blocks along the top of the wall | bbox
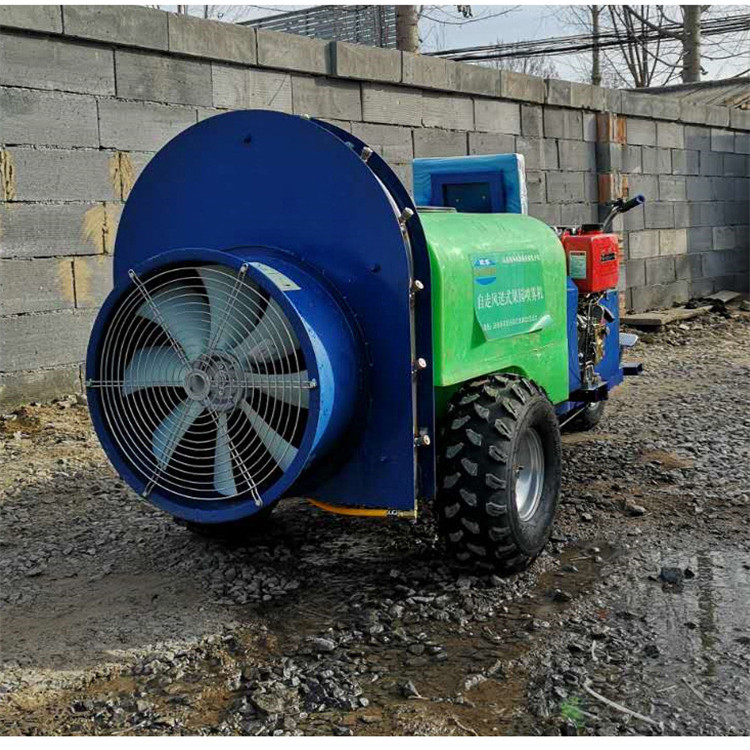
[0,5,750,130]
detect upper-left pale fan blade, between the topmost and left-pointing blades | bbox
[138,282,211,360]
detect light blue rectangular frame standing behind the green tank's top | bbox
[413,154,526,214]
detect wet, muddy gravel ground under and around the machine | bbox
[0,306,750,735]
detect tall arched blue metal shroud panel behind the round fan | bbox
[89,111,434,510]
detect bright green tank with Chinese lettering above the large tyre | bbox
[419,212,568,407]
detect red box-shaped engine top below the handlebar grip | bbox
[561,227,620,293]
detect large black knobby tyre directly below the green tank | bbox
[436,373,561,573]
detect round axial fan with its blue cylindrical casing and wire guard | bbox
[88,250,368,519]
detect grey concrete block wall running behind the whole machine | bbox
[0,6,750,406]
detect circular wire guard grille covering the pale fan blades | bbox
[89,265,315,505]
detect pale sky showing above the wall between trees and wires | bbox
[160,0,750,83]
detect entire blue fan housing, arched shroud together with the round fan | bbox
[87,111,435,523]
